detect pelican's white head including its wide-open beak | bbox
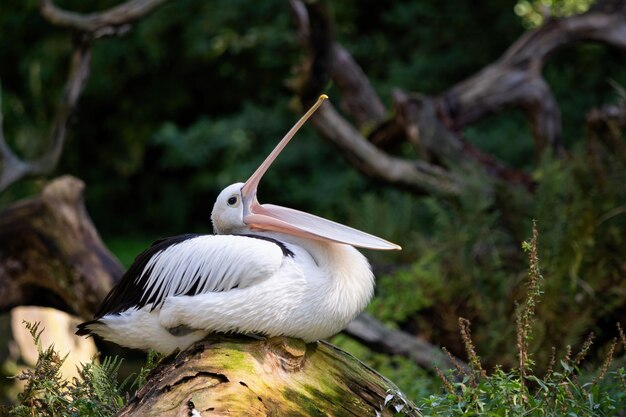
[211,95,401,250]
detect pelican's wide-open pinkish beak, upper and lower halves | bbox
[236,95,401,250]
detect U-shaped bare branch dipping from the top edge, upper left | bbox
[39,0,166,38]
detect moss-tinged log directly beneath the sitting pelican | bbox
[118,335,421,417]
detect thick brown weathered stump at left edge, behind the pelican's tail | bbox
[0,176,124,318]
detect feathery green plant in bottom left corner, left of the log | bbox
[9,323,160,417]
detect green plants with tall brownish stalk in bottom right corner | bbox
[421,223,626,416]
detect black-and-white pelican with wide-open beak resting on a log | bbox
[76,95,400,354]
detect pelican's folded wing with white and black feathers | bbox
[95,234,293,319]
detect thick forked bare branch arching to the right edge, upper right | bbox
[438,9,626,154]
